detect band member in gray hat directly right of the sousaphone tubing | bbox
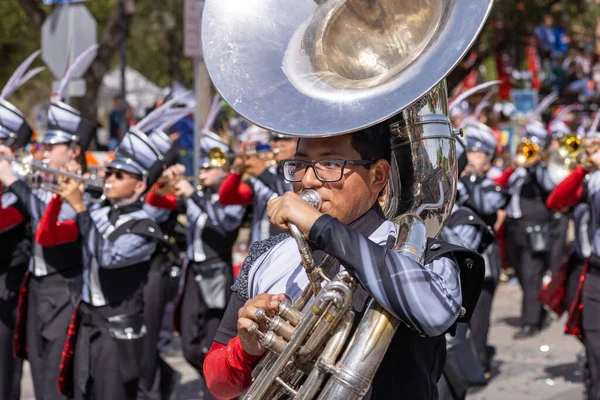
[458,122,510,378]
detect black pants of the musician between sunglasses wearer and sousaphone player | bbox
[181,264,233,400]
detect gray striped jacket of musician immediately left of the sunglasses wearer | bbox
[9,180,81,276]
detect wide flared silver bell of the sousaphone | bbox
[202,0,492,136]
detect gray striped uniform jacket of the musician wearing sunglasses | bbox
[77,204,160,306]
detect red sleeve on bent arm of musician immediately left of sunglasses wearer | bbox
[35,194,79,247]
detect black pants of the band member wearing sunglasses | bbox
[74,289,144,400]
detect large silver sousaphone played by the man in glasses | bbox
[202,0,492,400]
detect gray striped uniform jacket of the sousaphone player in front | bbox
[234,215,462,337]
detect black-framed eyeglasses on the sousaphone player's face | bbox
[281,159,375,182]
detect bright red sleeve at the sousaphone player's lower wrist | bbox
[202,336,262,400]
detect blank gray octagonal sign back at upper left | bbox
[42,4,96,79]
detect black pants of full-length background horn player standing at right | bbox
[506,220,548,327]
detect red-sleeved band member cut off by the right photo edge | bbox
[539,137,600,400]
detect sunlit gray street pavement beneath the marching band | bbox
[21,283,583,400]
